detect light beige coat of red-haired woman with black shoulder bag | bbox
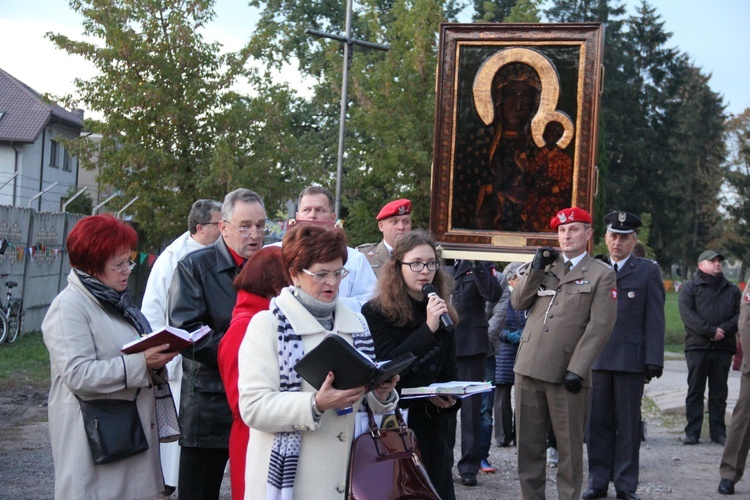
[42,271,164,500]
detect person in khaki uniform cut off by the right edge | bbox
[719,284,750,495]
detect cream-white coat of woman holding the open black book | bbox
[239,288,396,499]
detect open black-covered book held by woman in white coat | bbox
[294,335,417,390]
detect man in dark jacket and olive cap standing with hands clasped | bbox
[679,250,741,445]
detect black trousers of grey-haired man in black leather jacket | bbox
[177,446,229,500]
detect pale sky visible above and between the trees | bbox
[0,0,750,114]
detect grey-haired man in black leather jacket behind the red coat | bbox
[169,189,266,500]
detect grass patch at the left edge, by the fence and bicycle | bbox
[0,332,50,390]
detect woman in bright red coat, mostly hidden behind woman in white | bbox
[219,246,289,500]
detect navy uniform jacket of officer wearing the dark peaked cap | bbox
[593,255,664,373]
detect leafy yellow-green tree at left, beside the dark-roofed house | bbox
[47,0,253,245]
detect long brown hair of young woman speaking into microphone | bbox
[371,229,458,326]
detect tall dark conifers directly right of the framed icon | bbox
[546,0,724,274]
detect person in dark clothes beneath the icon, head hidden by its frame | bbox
[448,260,503,486]
